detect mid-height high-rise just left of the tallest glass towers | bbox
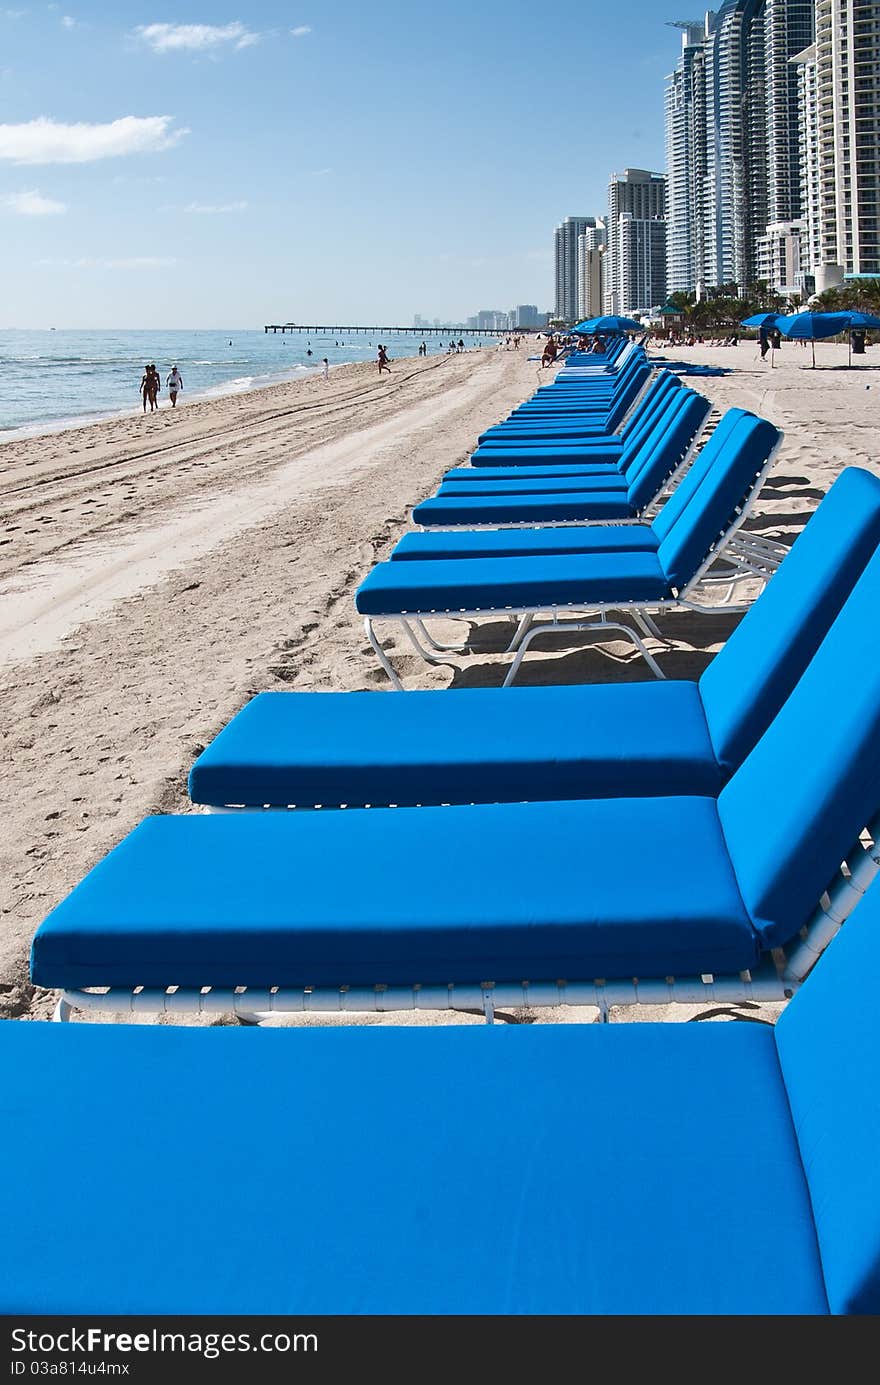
[604,169,667,314]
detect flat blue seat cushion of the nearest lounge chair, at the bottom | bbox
[0,1022,826,1312]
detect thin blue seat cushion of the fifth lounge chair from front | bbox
[391,524,657,562]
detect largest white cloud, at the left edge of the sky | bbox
[0,115,190,163]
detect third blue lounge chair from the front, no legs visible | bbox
[190,467,880,809]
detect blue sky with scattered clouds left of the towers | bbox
[0,0,673,328]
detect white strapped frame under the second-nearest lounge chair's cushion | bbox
[53,810,880,1024]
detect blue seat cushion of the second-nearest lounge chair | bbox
[32,797,758,986]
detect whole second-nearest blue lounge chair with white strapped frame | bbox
[32,531,880,1030]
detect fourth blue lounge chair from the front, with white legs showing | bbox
[355,410,782,688]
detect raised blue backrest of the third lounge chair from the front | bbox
[700,467,880,773]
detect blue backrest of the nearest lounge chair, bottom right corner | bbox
[776,879,880,1313]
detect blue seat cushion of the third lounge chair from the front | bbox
[190,681,721,807]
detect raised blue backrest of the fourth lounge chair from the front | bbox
[657,414,782,591]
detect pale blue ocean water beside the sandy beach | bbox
[0,328,496,439]
